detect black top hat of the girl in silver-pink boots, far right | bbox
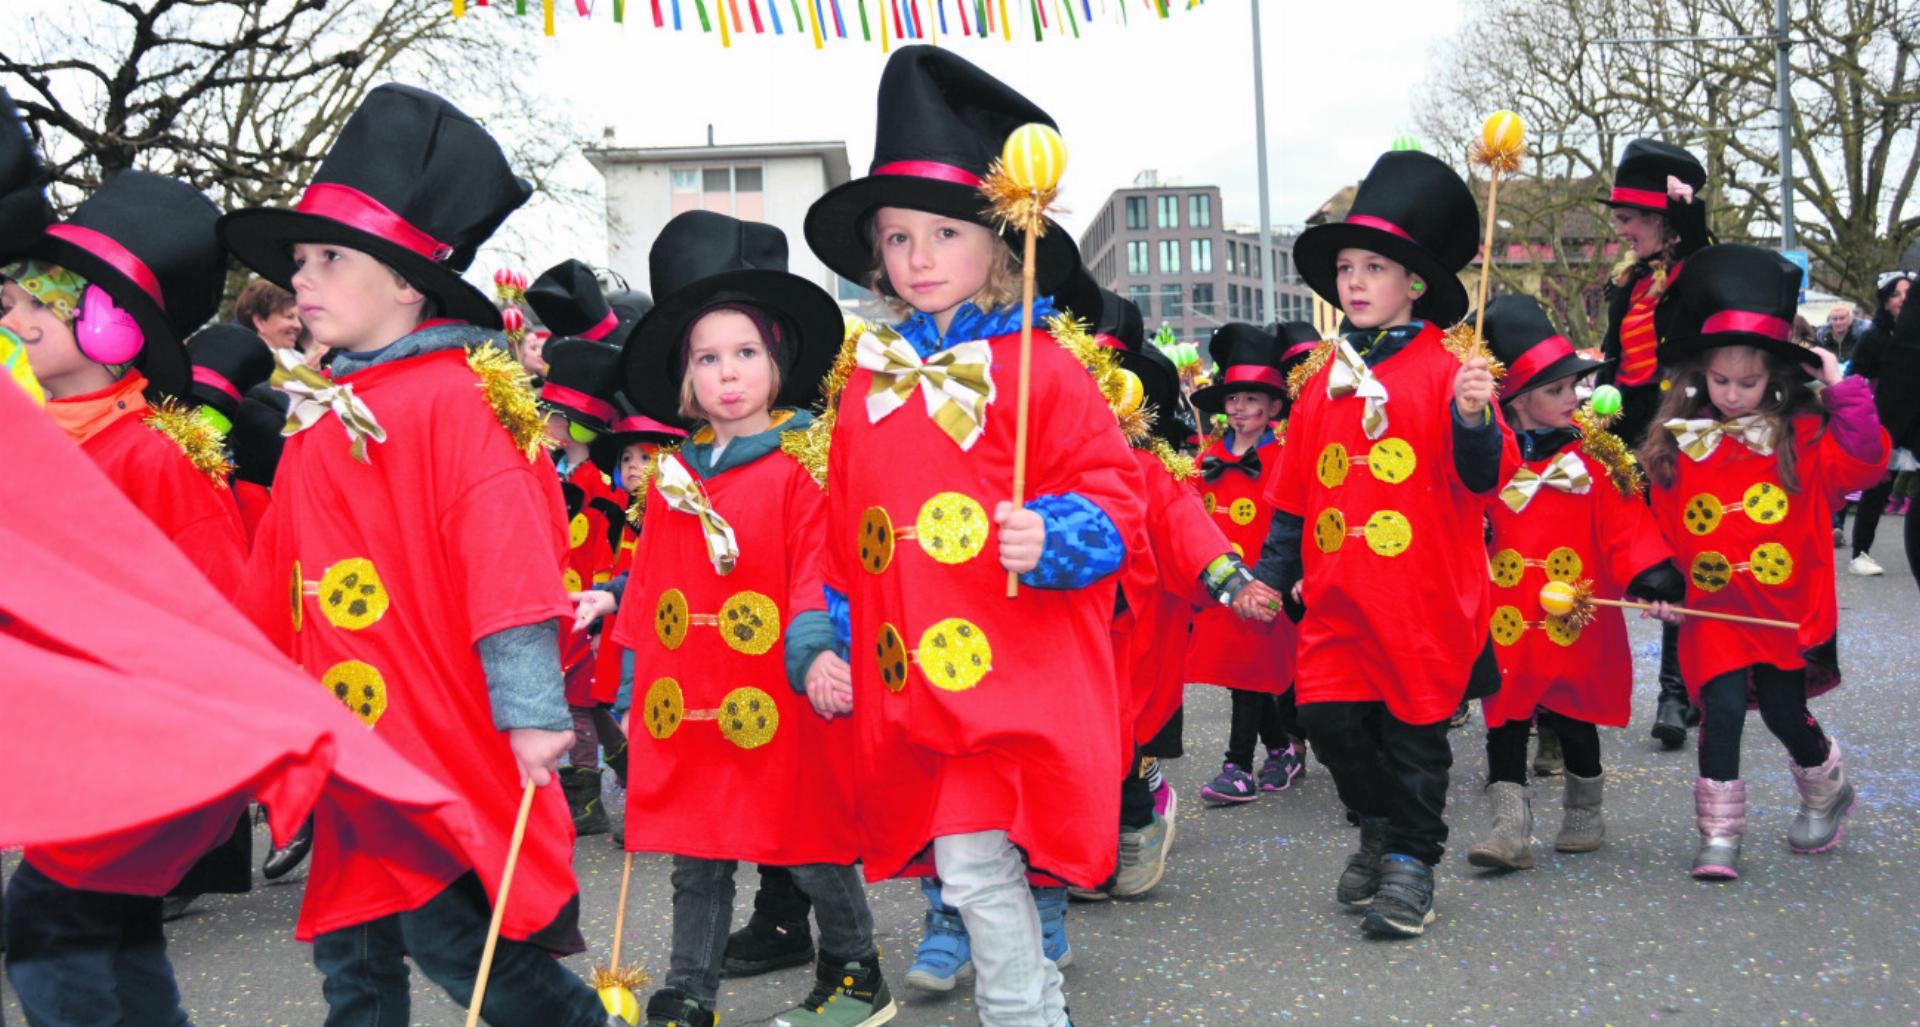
[1661,242,1814,367]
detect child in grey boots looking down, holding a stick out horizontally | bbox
[1467,296,1686,870]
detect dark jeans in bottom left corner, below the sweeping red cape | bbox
[6,862,190,1027]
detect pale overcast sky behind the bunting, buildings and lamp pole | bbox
[487,0,1459,273]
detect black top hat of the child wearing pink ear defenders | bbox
[27,171,227,395]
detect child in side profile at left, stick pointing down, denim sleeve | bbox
[221,84,607,1027]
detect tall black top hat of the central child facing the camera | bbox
[798,46,1085,299]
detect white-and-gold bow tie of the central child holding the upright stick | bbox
[854,328,995,449]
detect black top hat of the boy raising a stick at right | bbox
[1294,150,1480,328]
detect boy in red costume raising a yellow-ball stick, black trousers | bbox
[1236,152,1517,937]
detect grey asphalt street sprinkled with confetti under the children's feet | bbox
[0,518,1920,1027]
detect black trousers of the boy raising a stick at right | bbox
[1300,703,1453,866]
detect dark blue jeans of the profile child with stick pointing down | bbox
[313,873,607,1027]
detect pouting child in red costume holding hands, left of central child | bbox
[614,211,895,1027]
